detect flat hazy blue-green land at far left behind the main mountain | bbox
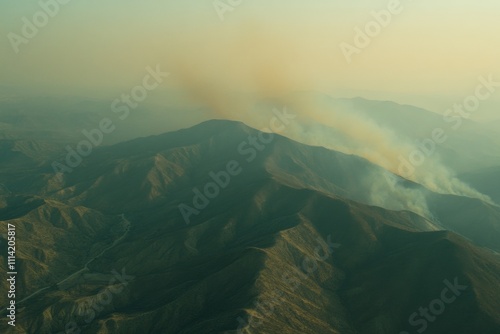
[0,95,201,184]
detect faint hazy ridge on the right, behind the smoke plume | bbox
[289,92,500,174]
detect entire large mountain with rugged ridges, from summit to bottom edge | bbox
[0,121,500,334]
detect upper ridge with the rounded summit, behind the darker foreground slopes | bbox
[7,121,500,250]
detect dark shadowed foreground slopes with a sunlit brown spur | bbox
[0,180,500,333]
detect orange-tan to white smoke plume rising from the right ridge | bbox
[166,21,492,217]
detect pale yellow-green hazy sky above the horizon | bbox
[0,0,500,117]
